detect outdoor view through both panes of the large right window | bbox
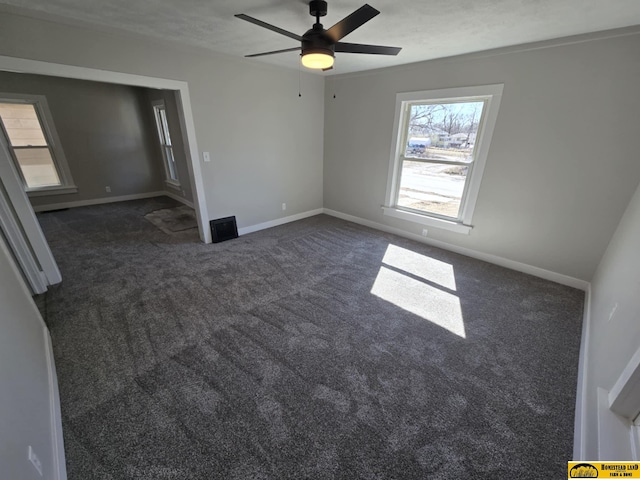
[396,100,486,219]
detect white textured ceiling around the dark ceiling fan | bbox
[0,0,640,75]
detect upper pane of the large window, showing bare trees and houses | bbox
[404,101,484,163]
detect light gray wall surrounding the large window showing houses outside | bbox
[324,31,640,281]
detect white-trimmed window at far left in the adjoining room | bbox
[0,94,78,196]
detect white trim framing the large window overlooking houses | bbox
[382,84,504,234]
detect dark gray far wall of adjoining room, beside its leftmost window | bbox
[0,72,164,206]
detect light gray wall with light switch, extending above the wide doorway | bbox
[0,8,324,227]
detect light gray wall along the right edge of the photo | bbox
[583,180,640,460]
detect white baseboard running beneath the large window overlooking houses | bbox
[323,208,589,291]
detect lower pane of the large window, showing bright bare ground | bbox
[397,161,469,218]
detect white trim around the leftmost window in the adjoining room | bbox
[0,93,78,197]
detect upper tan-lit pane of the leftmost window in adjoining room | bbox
[0,103,47,147]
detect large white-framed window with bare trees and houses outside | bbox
[383,85,502,233]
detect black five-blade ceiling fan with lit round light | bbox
[236,0,402,70]
